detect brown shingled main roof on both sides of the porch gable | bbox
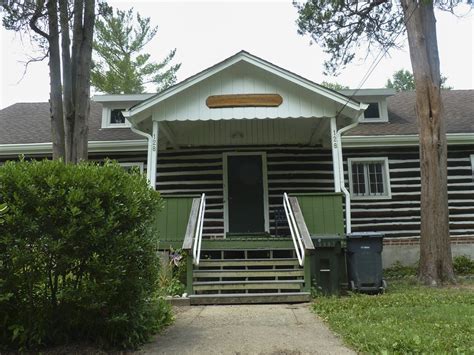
[0,90,474,154]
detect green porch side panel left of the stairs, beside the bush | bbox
[156,196,194,249]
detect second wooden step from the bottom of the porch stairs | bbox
[193,280,304,291]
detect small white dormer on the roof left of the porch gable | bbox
[92,94,155,128]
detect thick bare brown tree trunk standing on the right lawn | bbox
[401,0,454,286]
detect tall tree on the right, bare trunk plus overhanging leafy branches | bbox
[295,0,460,285]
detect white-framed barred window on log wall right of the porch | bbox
[348,158,391,199]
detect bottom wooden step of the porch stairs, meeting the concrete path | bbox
[189,292,311,305]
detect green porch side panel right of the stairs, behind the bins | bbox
[292,193,344,236]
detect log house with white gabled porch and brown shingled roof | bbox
[0,51,474,303]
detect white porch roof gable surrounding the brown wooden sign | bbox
[124,51,367,131]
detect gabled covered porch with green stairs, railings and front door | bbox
[124,52,366,303]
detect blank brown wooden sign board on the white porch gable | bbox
[206,94,283,108]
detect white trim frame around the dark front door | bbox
[222,152,270,236]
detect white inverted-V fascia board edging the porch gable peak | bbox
[123,52,366,118]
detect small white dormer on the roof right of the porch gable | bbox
[339,89,396,123]
